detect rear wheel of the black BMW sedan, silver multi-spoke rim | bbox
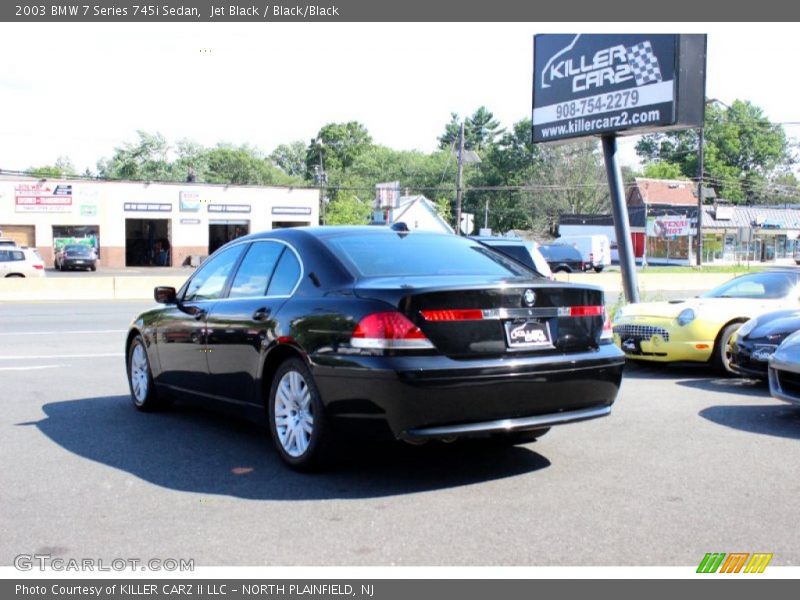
[267,358,333,472]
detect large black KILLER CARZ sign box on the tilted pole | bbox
[532,34,705,142]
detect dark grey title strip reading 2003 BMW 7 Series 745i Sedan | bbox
[0,0,800,23]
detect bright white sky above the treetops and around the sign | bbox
[0,23,800,172]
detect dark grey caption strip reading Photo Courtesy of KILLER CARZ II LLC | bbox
[0,575,795,600]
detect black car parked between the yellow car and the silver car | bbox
[730,308,800,379]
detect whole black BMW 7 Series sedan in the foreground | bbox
[125,227,624,469]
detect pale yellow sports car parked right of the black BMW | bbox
[613,267,800,373]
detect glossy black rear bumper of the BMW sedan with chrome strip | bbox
[312,344,624,439]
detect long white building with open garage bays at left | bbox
[0,177,319,267]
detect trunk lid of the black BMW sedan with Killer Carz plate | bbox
[355,277,605,358]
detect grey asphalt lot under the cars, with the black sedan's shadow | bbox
[0,301,800,566]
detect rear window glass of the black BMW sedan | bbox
[322,232,532,277]
